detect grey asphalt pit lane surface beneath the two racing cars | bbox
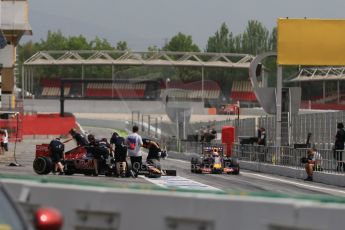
[0,124,345,197]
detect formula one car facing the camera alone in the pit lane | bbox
[191,145,240,175]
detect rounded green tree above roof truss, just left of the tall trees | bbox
[163,32,200,52]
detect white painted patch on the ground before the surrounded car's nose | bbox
[143,176,222,191]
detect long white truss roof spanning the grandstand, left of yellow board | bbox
[24,50,254,68]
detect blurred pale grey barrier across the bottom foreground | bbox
[2,180,345,230]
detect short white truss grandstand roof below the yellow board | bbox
[288,67,345,82]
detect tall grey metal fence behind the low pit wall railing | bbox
[187,111,345,149]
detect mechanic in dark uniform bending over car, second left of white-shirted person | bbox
[87,134,111,176]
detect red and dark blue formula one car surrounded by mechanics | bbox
[33,144,176,178]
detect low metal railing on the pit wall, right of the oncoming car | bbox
[232,143,345,174]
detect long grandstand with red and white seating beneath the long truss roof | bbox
[40,78,264,104]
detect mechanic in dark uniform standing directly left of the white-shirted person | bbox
[110,132,127,177]
